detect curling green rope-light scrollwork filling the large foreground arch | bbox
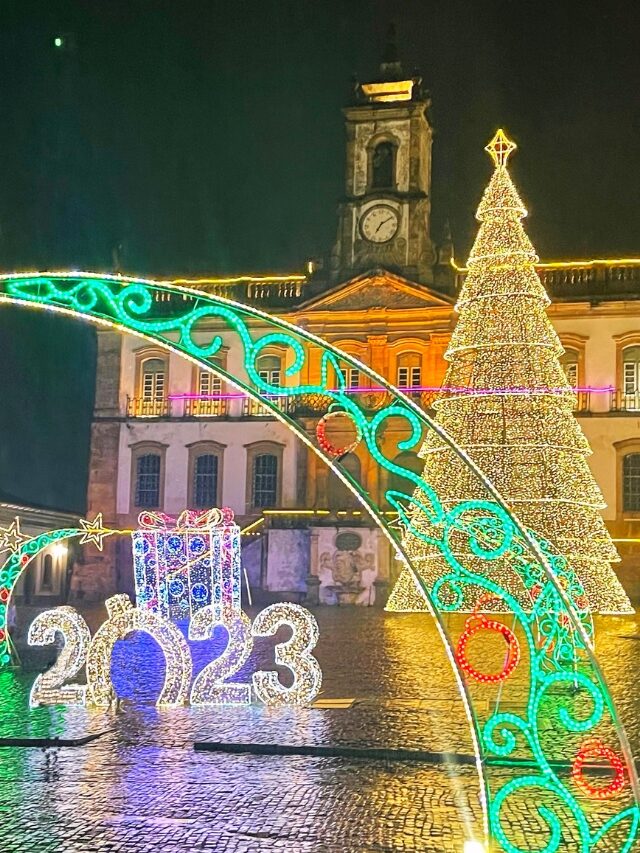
[0,274,640,853]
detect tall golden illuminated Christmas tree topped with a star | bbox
[388,130,633,613]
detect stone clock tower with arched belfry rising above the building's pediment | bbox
[332,27,435,284]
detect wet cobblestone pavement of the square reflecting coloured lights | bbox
[0,608,640,853]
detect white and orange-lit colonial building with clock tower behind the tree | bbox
[79,57,640,604]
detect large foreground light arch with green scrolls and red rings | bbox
[0,273,640,853]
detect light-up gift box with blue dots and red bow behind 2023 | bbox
[131,507,241,622]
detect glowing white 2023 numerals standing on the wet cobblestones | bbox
[28,595,322,707]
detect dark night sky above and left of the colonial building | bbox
[0,0,640,510]
